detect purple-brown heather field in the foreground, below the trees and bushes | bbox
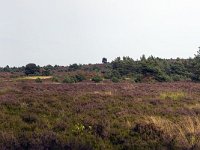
[0,77,200,150]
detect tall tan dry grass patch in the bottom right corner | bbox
[145,116,200,149]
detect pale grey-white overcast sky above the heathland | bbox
[0,0,200,66]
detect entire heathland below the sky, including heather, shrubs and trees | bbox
[0,53,200,150]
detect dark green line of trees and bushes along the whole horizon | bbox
[0,50,200,82]
